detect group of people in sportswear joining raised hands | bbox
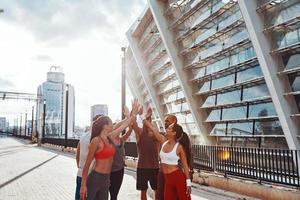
[75,100,192,200]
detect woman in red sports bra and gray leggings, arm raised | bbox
[80,100,139,200]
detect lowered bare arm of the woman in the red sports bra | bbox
[80,138,103,200]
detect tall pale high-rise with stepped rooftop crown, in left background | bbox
[37,66,75,138]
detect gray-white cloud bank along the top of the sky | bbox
[1,0,145,46]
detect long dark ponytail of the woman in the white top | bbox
[173,124,193,169]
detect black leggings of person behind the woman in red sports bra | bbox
[109,168,124,200]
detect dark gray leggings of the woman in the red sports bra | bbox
[86,170,110,200]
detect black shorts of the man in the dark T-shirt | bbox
[136,168,158,190]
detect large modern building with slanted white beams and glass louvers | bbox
[125,0,300,149]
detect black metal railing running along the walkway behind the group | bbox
[16,138,300,187]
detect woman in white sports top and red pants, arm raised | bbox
[144,115,191,200]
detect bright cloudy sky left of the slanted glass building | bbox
[0,0,146,126]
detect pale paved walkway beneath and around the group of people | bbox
[0,136,258,200]
